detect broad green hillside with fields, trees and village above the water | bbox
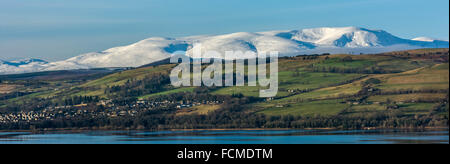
[0,48,449,128]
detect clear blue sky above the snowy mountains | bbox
[0,0,449,61]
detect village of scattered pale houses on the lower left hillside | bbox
[0,99,223,123]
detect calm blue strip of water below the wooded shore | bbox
[0,129,449,144]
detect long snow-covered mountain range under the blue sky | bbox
[0,27,449,74]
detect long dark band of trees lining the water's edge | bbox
[0,104,448,130]
